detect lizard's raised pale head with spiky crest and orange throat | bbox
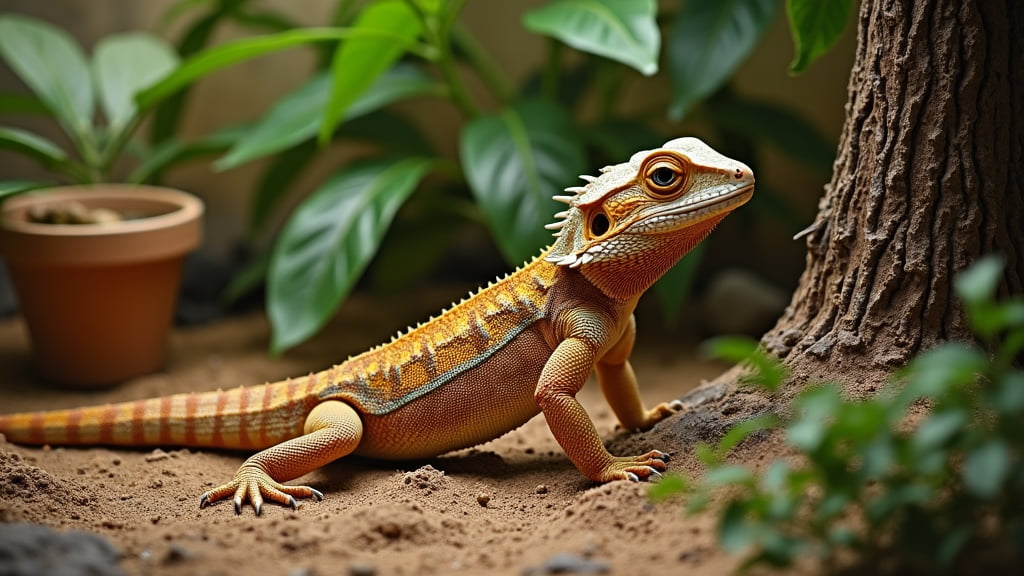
[545,137,754,298]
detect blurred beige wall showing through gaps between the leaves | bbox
[0,0,854,286]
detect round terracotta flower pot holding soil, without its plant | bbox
[0,184,203,386]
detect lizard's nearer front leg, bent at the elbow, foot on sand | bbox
[536,337,668,482]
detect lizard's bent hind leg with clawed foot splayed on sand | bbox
[200,400,362,516]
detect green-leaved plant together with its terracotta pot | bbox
[0,14,203,386]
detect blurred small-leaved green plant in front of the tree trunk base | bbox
[652,257,1024,573]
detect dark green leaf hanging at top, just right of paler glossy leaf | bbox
[669,0,778,120]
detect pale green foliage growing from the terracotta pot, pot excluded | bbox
[0,14,232,197]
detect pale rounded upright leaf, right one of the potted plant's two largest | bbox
[92,32,178,134]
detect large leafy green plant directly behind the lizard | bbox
[151,0,848,352]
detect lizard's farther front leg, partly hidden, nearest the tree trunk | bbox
[595,315,683,430]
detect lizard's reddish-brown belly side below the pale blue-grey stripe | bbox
[356,330,552,459]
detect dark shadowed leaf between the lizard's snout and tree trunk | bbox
[708,97,837,174]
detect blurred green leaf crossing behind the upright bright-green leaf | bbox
[215,66,440,170]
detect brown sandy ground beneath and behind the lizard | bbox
[0,286,738,576]
